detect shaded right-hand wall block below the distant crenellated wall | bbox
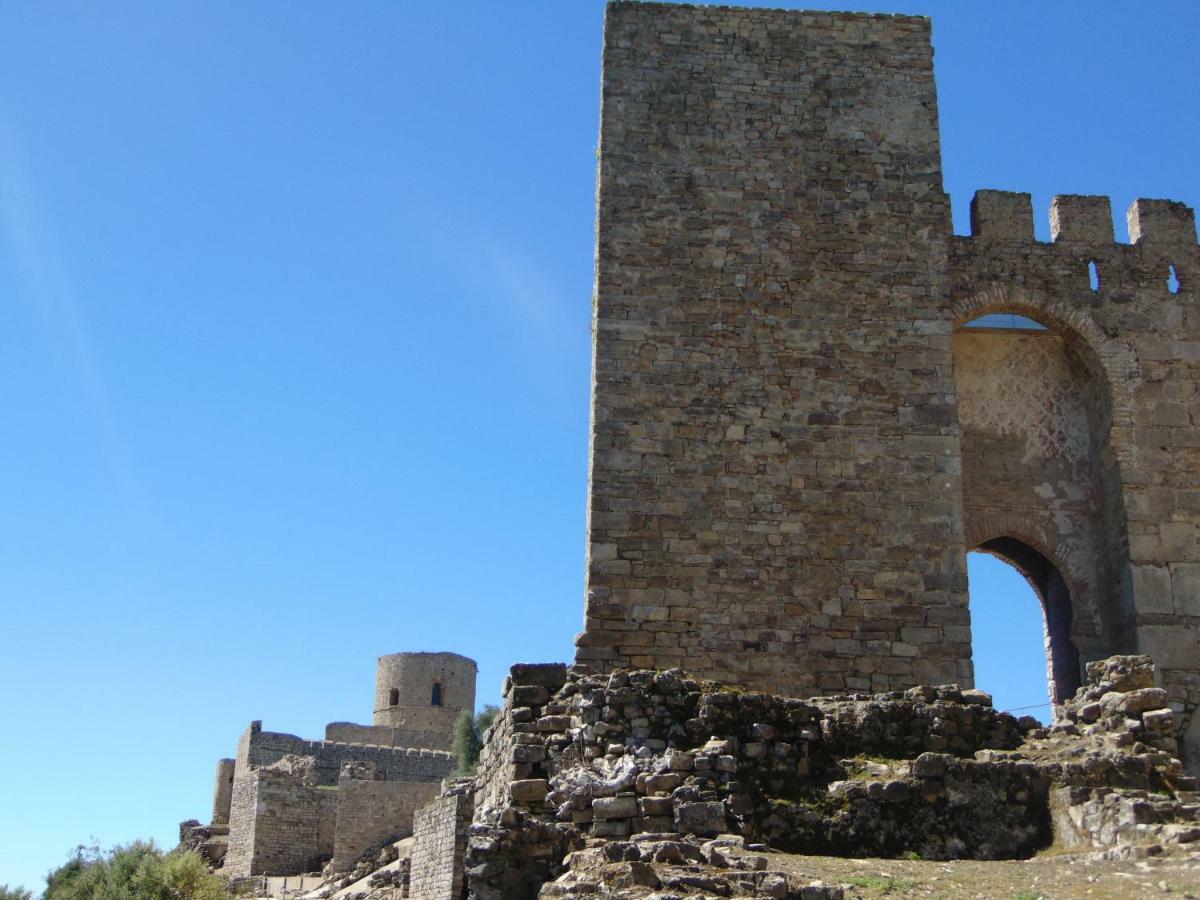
[332,772,440,871]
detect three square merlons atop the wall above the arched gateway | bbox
[971,190,1196,250]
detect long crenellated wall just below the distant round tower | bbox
[238,721,455,785]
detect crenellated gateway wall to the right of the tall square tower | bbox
[949,191,1200,767]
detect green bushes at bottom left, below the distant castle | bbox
[44,841,230,900]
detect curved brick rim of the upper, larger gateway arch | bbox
[950,284,1140,467]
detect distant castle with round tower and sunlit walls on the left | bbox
[181,653,476,877]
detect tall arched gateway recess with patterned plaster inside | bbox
[952,286,1139,657]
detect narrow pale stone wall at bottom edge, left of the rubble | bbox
[409,782,474,900]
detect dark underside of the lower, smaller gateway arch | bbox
[967,527,1084,706]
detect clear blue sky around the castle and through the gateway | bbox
[0,0,1200,888]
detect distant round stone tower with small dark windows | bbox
[374,653,479,750]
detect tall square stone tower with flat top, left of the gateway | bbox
[576,2,972,695]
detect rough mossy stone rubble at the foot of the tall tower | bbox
[453,656,1200,900]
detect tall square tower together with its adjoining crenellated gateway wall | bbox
[576,2,1200,767]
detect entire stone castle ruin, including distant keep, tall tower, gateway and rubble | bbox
[177,2,1200,900]
